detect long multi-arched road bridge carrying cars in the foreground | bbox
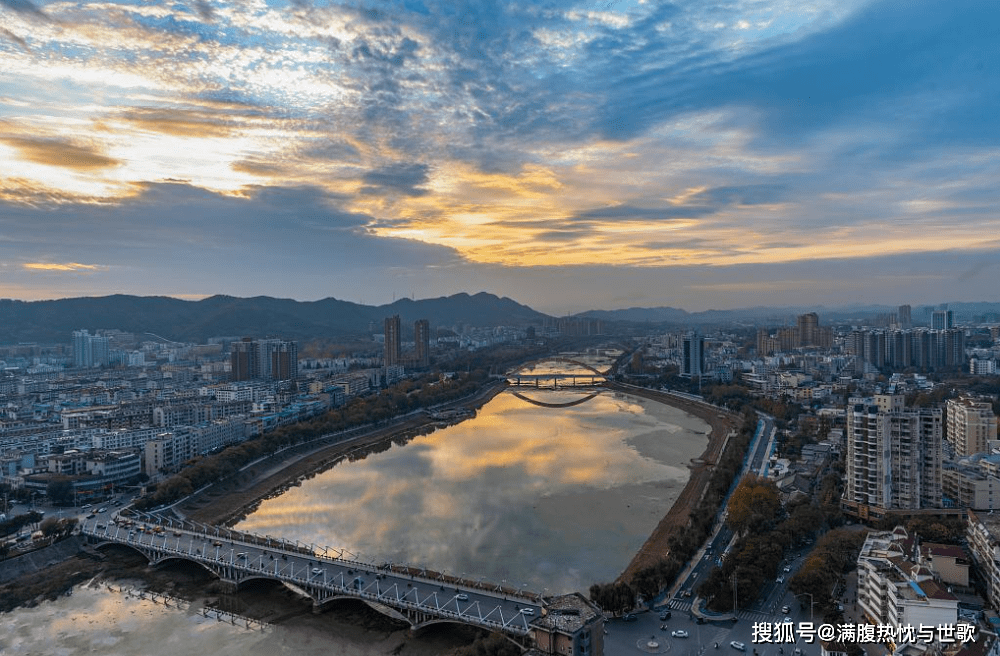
[81,514,545,647]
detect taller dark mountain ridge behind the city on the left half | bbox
[0,292,547,344]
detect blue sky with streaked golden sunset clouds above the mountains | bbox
[0,0,1000,314]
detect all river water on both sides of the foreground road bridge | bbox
[0,382,709,656]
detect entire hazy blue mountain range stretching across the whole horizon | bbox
[0,292,1000,344]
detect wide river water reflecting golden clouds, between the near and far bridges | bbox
[238,389,709,593]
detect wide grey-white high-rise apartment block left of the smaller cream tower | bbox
[844,401,943,517]
